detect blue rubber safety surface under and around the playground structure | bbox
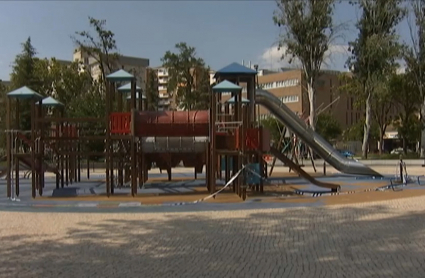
[0,173,425,213]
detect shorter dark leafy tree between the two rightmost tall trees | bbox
[390,72,422,153]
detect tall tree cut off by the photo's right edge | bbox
[403,0,425,157]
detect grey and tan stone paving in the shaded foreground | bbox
[0,197,425,278]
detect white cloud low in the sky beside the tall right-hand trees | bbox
[259,44,350,70]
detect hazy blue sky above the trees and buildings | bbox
[0,0,409,80]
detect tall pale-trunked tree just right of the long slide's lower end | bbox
[347,0,405,158]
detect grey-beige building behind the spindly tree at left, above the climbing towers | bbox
[72,49,149,90]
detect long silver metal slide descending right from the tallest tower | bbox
[255,90,382,177]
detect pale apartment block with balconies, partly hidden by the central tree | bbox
[154,67,215,111]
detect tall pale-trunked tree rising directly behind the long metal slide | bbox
[273,0,338,130]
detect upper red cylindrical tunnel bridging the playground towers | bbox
[135,110,209,137]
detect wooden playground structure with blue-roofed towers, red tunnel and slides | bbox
[2,63,380,199]
